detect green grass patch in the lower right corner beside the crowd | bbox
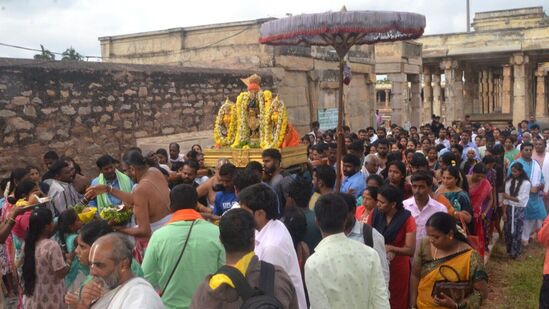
[482,241,545,309]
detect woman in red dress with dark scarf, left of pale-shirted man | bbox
[368,185,416,309]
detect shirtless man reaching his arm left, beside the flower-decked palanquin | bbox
[86,150,171,239]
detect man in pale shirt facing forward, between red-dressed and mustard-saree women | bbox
[402,170,448,248]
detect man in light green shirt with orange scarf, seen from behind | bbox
[142,184,225,308]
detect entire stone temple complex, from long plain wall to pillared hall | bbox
[99,7,549,129]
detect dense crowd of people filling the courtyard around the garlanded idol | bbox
[0,116,549,309]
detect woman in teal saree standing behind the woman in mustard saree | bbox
[437,161,475,233]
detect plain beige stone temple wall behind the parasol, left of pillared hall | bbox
[99,19,376,134]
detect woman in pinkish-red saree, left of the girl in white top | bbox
[467,163,494,256]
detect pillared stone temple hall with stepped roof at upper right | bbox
[417,7,549,125]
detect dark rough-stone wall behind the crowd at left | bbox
[0,58,273,176]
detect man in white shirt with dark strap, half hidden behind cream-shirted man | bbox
[338,193,390,288]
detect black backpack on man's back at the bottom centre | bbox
[217,261,283,309]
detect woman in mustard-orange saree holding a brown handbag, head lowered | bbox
[410,212,488,309]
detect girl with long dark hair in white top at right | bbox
[502,162,532,259]
